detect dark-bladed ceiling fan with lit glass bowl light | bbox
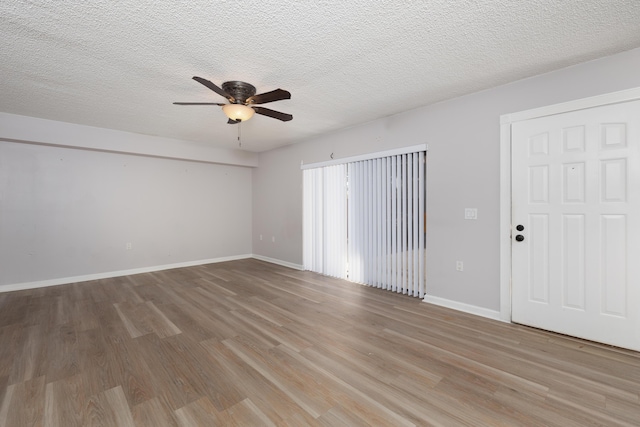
[174,76,293,125]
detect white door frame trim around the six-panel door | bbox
[500,87,640,323]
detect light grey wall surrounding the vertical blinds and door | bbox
[253,49,640,313]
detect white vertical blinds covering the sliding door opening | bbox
[303,147,426,297]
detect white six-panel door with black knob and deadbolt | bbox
[511,101,640,351]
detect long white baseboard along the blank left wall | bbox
[0,255,252,293]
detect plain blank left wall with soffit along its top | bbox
[0,115,257,291]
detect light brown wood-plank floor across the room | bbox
[0,260,640,427]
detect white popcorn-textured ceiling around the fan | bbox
[0,0,640,151]
